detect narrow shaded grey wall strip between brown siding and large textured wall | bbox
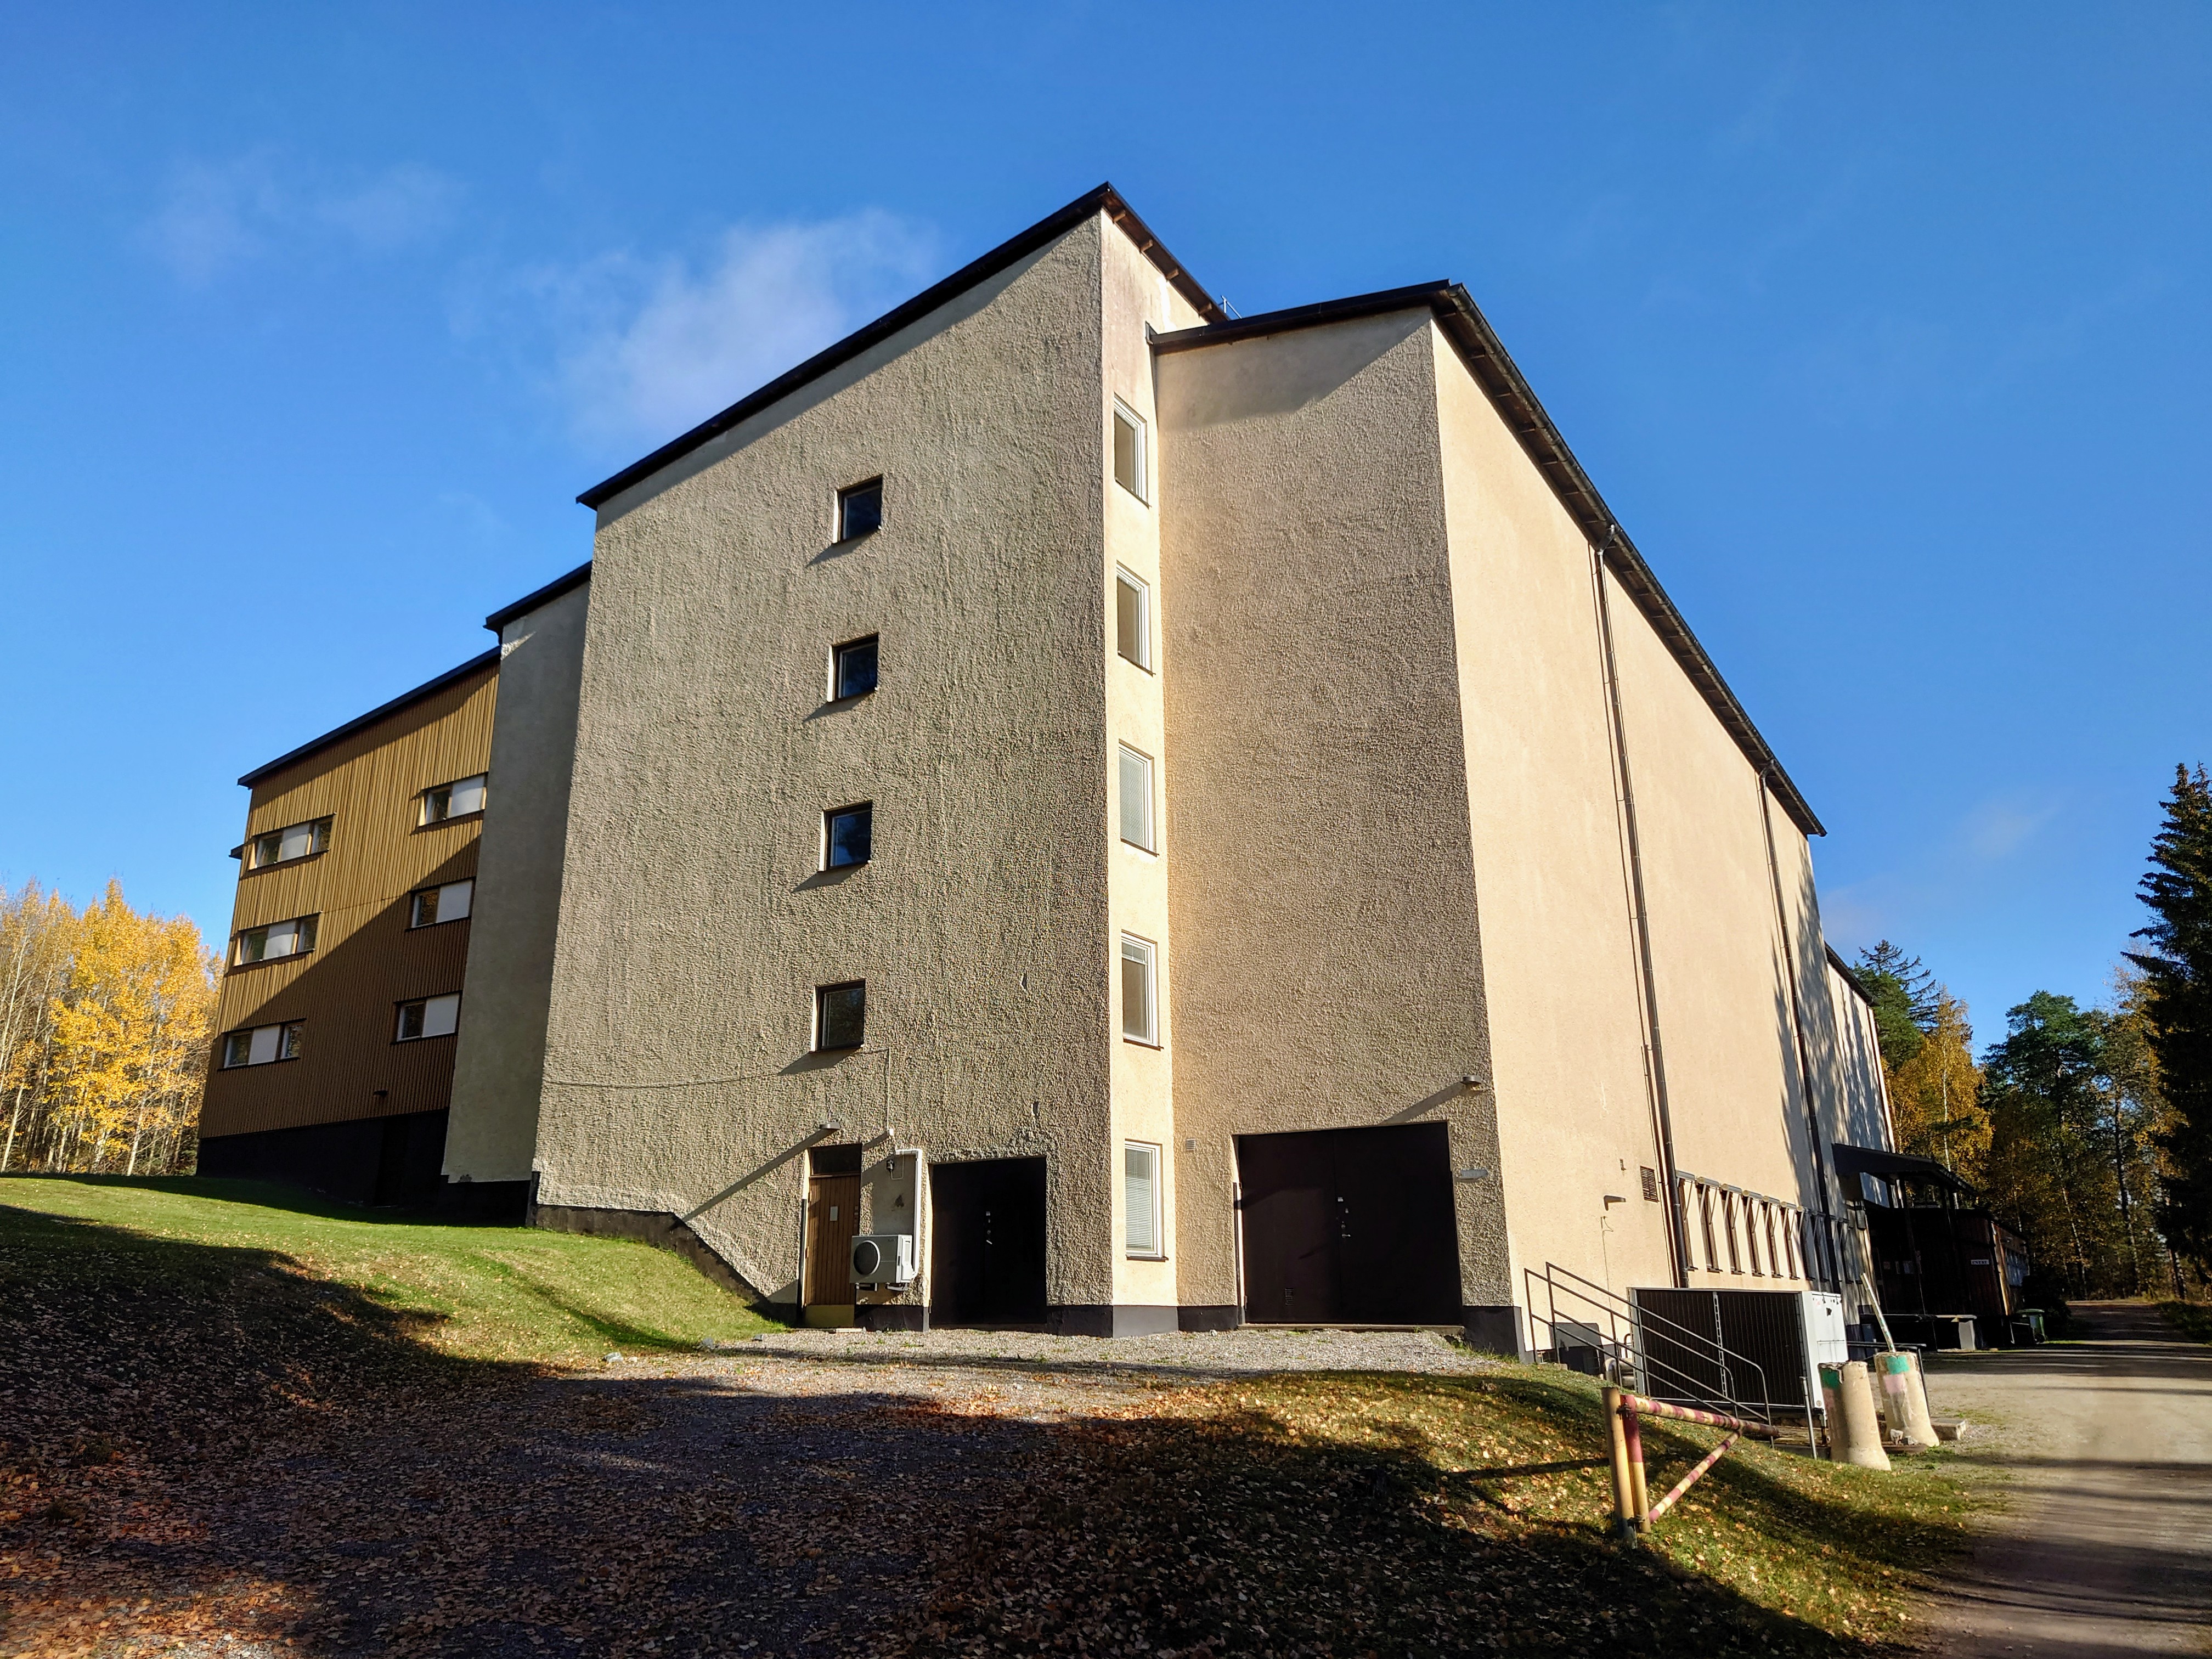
[444,582,591,1181]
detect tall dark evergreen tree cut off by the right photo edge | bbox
[2128,765,2212,1272]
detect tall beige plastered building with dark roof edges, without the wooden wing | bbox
[210,188,1889,1350]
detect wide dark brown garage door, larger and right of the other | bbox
[1237,1124,1460,1325]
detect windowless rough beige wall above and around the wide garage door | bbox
[1159,312,1506,1305]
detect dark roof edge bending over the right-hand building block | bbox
[1153,283,1827,836]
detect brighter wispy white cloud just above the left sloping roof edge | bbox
[537,210,936,442]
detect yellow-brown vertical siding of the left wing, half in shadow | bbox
[199,664,498,1135]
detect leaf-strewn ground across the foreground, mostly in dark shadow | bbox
[0,1212,1953,1655]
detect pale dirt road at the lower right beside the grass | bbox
[1929,1303,2212,1659]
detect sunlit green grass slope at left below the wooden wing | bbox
[0,1177,781,1365]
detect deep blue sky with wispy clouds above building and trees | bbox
[0,4,2212,1037]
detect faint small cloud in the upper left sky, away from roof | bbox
[146,150,462,285]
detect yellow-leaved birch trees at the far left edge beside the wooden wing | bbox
[0,883,215,1175]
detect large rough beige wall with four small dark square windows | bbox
[538,221,1113,1303]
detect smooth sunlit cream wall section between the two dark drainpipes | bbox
[1606,575,1818,1232]
